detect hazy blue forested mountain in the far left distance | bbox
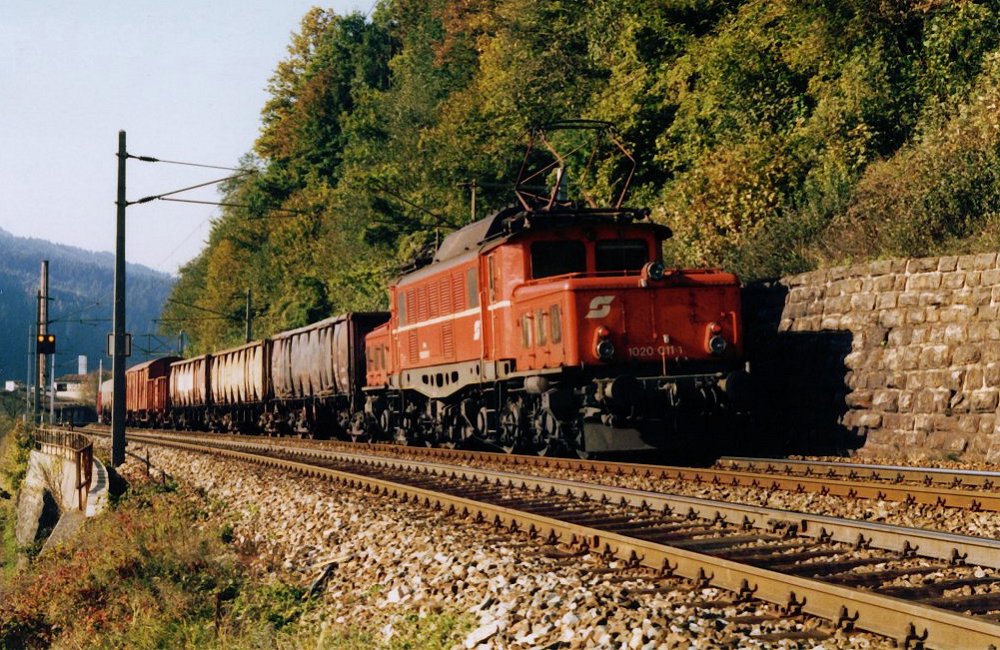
[0,229,176,381]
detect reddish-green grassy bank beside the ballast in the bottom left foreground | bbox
[0,468,471,649]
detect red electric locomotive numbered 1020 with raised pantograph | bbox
[362,121,747,455]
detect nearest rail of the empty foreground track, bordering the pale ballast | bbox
[113,430,1000,649]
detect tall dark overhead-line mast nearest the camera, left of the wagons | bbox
[111,131,128,467]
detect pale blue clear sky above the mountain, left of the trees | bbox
[0,0,374,273]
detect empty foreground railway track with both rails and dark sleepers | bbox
[82,426,1000,648]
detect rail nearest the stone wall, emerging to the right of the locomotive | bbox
[718,456,1000,490]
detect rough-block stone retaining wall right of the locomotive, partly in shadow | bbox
[744,253,1000,462]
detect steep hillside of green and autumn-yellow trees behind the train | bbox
[168,0,1000,350]
